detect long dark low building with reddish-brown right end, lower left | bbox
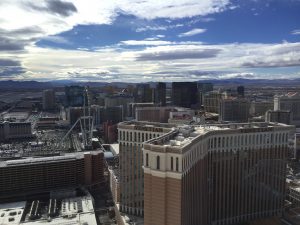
[0,151,104,200]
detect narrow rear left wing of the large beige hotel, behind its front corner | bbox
[118,122,172,216]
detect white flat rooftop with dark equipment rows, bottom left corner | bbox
[0,190,97,225]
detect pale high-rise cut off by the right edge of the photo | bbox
[274,92,300,127]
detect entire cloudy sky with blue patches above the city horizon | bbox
[0,0,300,82]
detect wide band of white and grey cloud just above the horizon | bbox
[1,43,300,82]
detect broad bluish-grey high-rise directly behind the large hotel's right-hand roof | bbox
[219,98,250,122]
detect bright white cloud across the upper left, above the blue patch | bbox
[0,0,231,56]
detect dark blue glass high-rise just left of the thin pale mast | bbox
[65,86,87,107]
